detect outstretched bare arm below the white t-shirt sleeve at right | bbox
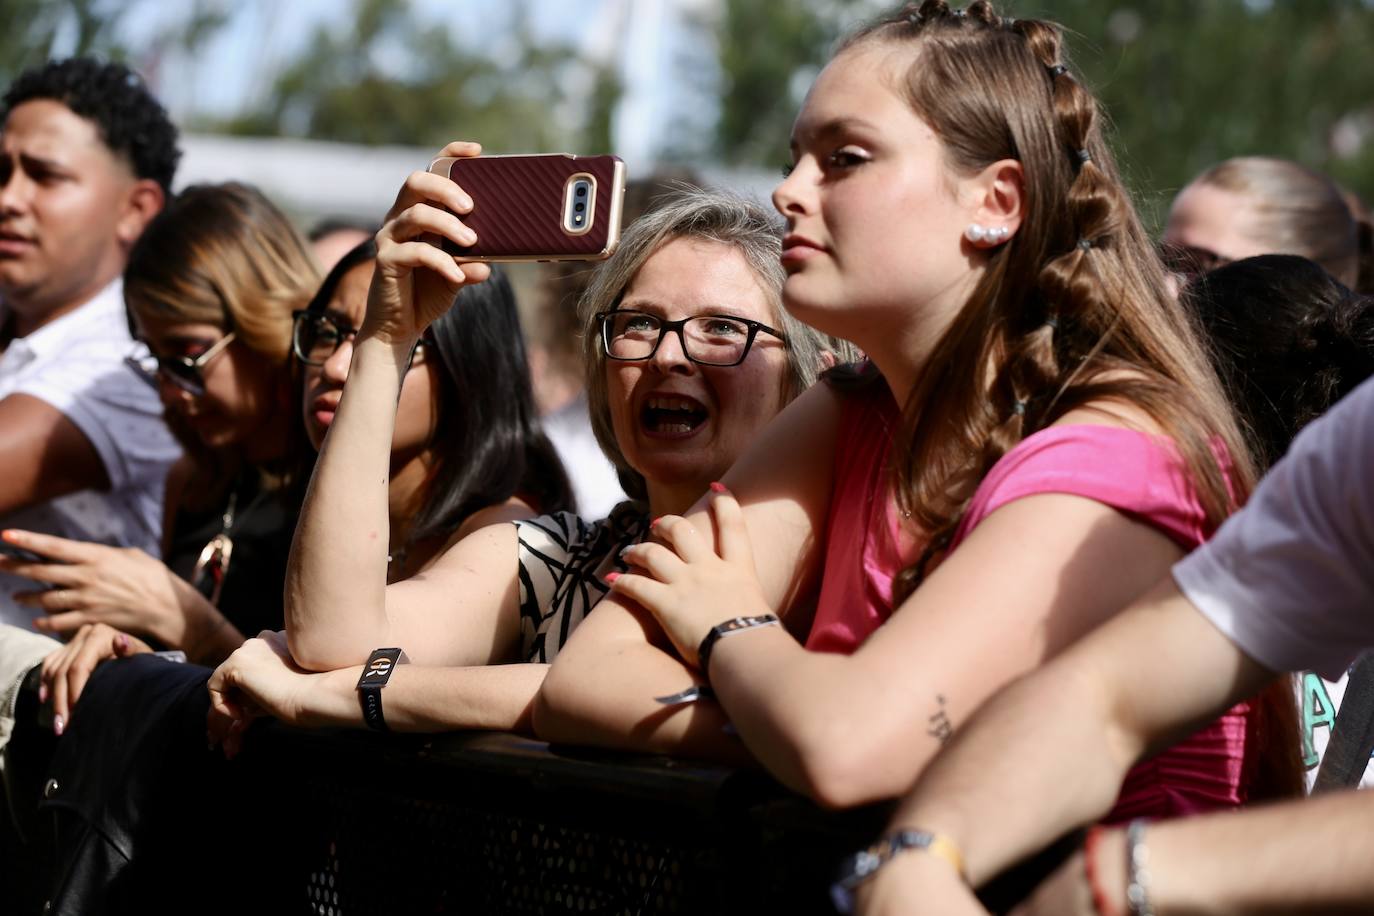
[860,578,1274,915]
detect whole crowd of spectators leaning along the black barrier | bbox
[0,0,1374,916]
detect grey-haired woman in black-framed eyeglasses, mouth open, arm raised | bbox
[210,182,826,750]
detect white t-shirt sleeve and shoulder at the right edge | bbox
[1173,379,1374,681]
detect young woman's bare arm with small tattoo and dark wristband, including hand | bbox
[616,480,1180,808]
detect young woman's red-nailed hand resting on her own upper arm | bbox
[607,483,772,666]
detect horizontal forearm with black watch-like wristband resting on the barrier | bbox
[301,663,548,733]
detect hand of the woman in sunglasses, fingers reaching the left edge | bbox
[0,529,205,648]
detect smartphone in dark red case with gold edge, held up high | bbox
[429,152,625,261]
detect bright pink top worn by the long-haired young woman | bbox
[807,385,1250,823]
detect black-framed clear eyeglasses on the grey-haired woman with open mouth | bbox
[595,309,787,365]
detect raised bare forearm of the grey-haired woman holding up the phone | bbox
[284,338,407,670]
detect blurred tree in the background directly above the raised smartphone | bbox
[220,0,620,151]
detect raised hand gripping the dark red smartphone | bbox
[363,140,491,347]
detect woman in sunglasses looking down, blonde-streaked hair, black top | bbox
[4,184,319,694]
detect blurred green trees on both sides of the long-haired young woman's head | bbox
[714,0,1374,225]
